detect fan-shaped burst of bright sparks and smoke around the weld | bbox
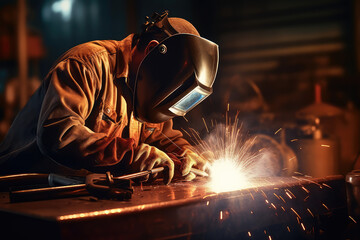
[197,118,280,193]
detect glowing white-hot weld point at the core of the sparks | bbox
[210,159,249,193]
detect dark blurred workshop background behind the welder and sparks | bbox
[0,0,360,176]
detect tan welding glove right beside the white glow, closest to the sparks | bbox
[180,149,209,181]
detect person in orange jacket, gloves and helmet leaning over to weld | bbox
[0,12,218,183]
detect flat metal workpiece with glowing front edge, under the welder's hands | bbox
[0,176,349,240]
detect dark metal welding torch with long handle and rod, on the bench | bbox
[5,167,208,202]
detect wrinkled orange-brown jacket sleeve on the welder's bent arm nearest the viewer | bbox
[37,60,134,171]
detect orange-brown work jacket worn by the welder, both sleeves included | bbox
[0,35,189,173]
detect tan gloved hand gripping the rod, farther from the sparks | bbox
[131,143,174,184]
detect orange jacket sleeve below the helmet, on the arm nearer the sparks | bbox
[145,120,192,155]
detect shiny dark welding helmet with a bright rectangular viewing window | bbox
[134,33,219,123]
